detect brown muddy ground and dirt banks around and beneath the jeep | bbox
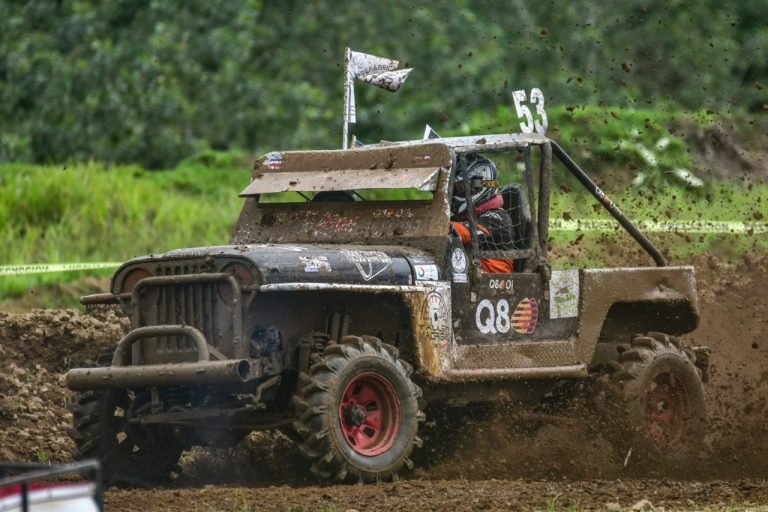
[0,255,768,511]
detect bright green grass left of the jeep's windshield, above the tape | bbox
[0,150,250,297]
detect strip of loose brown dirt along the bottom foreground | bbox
[106,480,768,512]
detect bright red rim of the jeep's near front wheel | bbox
[339,372,400,457]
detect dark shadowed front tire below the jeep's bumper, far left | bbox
[68,352,183,486]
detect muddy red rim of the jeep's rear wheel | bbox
[645,373,690,448]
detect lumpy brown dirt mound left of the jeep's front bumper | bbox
[0,310,127,462]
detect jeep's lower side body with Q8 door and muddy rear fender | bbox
[440,267,698,376]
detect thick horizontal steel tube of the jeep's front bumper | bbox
[66,359,254,391]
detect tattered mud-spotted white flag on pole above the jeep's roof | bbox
[346,48,412,123]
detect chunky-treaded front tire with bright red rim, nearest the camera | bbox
[293,336,425,482]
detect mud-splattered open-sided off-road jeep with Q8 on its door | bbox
[66,134,706,481]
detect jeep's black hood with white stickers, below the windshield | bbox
[113,244,442,290]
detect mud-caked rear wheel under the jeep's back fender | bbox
[611,332,706,468]
